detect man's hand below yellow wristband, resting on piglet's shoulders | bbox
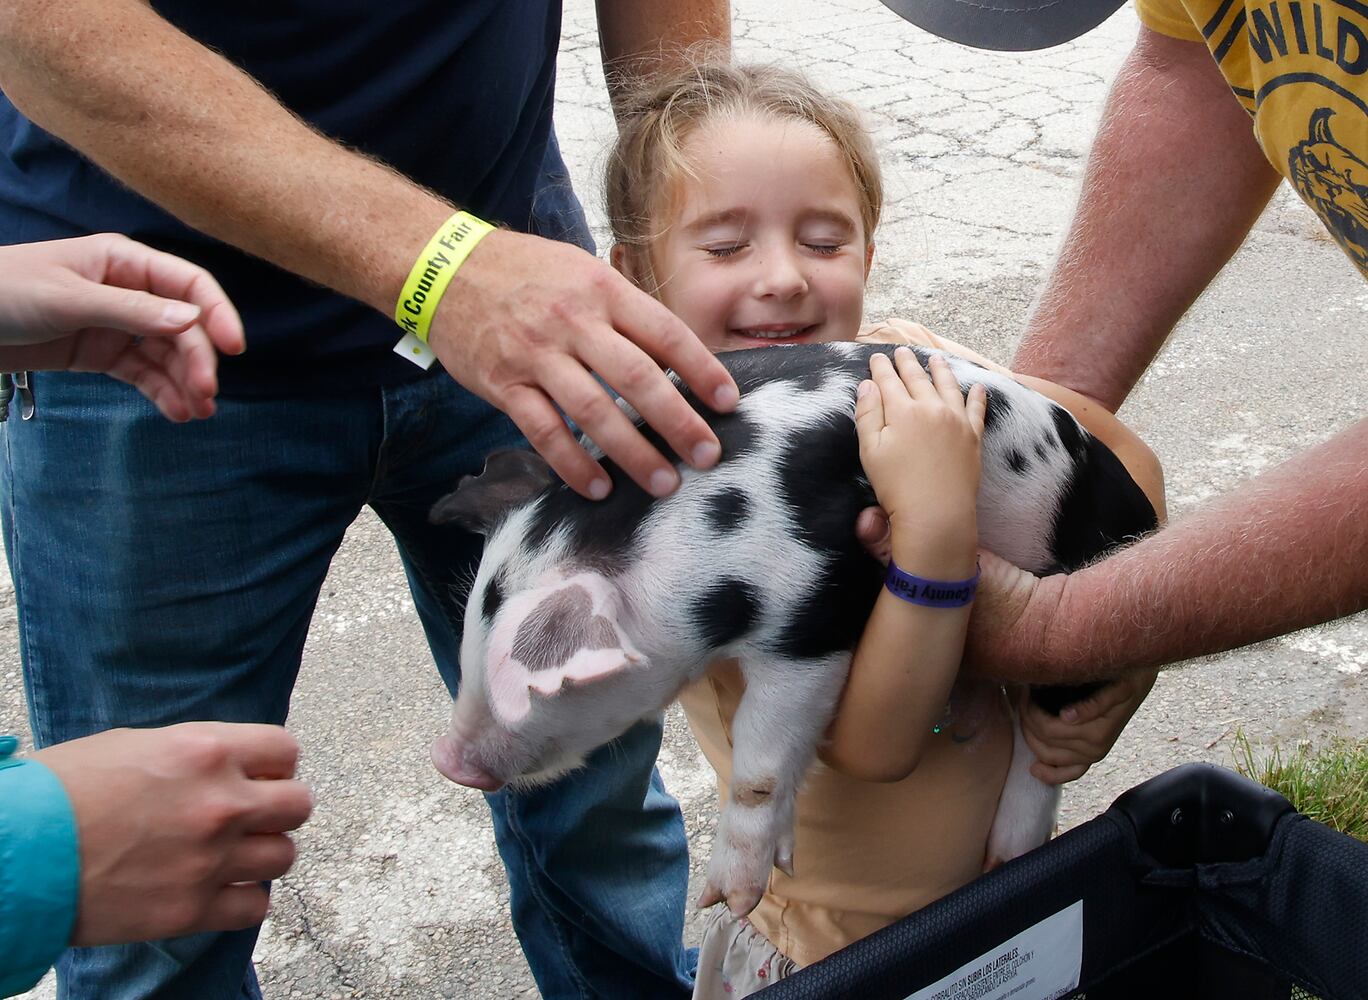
[428,230,739,499]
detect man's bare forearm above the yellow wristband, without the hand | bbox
[0,0,450,317]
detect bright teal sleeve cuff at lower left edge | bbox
[0,736,81,996]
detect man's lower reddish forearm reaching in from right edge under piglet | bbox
[1015,420,1368,681]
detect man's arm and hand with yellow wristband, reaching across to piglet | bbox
[0,0,736,492]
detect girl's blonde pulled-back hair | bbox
[606,59,884,291]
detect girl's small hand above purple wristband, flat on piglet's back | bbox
[855,347,988,575]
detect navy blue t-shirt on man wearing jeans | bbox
[0,0,588,394]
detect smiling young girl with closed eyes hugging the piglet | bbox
[607,64,1163,1000]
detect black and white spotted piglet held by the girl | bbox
[432,343,1156,912]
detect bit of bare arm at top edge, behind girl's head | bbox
[596,0,732,111]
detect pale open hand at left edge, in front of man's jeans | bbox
[0,234,245,421]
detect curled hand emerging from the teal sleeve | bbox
[34,722,313,945]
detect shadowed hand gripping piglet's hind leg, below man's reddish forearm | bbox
[1021,670,1159,785]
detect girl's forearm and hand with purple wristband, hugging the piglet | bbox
[821,349,986,781]
